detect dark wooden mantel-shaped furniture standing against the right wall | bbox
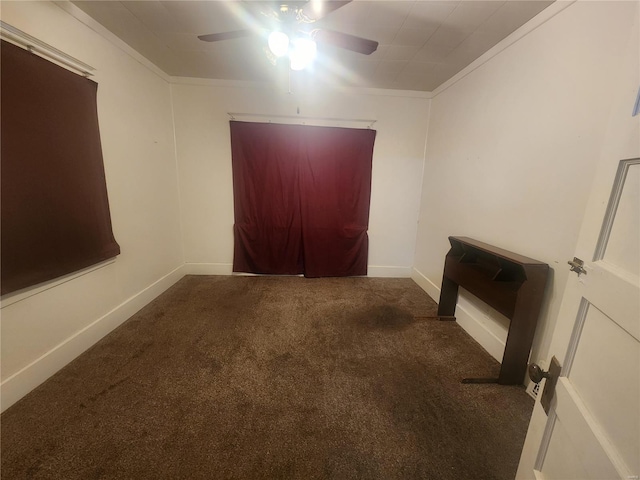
[438,237,549,385]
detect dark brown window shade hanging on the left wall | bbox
[0,41,120,295]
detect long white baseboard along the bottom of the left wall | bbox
[0,265,184,411]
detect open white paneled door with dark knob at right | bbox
[517,2,640,480]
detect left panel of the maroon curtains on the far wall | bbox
[231,122,303,275]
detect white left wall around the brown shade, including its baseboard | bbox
[1,2,183,409]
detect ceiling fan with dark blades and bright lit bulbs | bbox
[198,0,378,70]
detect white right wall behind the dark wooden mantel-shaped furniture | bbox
[413,2,635,359]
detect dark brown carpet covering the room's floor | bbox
[1,276,533,480]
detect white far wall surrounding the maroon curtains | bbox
[173,80,429,277]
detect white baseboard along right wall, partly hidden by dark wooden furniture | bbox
[411,268,505,362]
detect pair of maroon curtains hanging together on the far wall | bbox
[230,122,376,277]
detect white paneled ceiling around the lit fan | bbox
[72,0,552,91]
